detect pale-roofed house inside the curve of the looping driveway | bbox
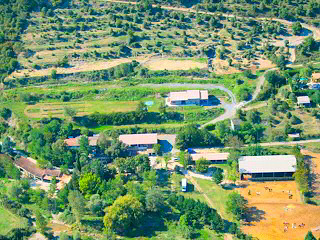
[167,90,209,106]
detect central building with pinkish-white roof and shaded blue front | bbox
[119,133,158,151]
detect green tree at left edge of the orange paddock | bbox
[226,192,248,220]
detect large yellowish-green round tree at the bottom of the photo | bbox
[103,194,143,233]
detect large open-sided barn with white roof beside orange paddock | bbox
[239,155,297,181]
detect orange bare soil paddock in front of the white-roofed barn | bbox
[239,181,320,240]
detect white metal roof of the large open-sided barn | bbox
[239,155,297,173]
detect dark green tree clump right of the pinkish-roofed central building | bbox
[176,125,221,150]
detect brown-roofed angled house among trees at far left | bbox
[14,157,62,181]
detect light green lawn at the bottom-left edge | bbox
[0,206,28,235]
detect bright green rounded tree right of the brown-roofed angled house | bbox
[79,172,101,197]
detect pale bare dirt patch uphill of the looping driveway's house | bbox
[145,59,208,70]
